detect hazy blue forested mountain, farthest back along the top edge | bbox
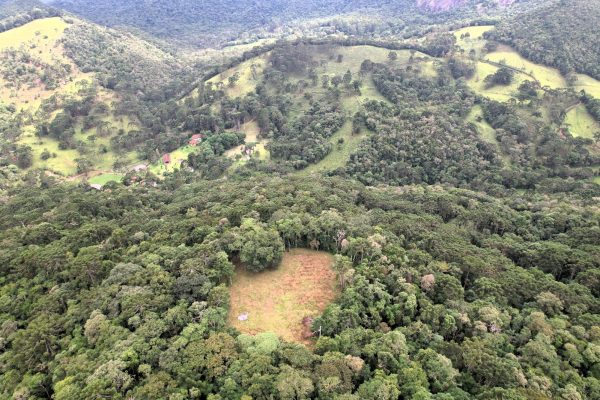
[52,0,414,45]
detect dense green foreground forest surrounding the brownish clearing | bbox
[0,171,600,400]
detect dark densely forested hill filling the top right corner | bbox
[488,0,600,79]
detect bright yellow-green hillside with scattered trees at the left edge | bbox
[0,17,192,185]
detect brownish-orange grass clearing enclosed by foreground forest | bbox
[229,249,338,344]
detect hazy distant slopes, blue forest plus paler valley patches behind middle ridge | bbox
[52,0,520,47]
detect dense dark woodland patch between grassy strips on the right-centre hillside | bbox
[345,65,498,188]
